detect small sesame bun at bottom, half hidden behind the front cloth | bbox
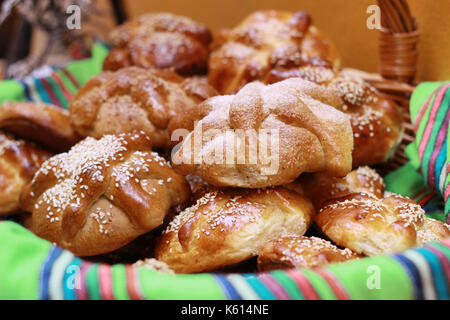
[258,236,359,272]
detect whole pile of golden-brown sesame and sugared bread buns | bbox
[0,11,450,273]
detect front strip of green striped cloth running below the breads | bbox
[0,222,442,300]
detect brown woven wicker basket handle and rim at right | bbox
[359,0,420,173]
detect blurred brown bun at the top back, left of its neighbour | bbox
[103,12,212,75]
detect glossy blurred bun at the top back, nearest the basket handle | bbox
[208,10,340,94]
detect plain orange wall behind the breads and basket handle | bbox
[123,0,450,81]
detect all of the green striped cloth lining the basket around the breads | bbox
[0,44,450,300]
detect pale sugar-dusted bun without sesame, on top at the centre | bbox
[172,78,353,188]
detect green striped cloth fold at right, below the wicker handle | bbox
[385,82,450,223]
